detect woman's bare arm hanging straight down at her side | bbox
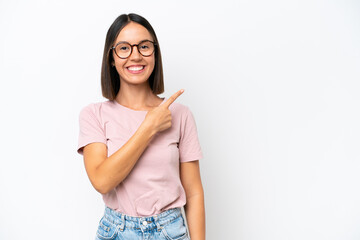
[180,160,205,240]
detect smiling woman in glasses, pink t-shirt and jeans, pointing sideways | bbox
[78,14,205,240]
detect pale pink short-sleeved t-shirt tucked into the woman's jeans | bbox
[77,98,203,217]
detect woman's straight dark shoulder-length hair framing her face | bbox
[101,13,164,100]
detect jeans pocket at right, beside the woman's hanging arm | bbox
[161,215,189,240]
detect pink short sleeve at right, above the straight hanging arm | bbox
[179,107,203,162]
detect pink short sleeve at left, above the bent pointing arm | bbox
[77,104,106,155]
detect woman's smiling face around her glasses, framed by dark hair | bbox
[112,22,155,87]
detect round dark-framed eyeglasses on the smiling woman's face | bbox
[111,40,156,59]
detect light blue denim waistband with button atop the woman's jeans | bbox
[104,206,182,231]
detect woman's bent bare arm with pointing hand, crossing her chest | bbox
[83,90,183,194]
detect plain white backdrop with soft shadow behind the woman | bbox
[0,0,360,240]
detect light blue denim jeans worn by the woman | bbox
[95,206,190,240]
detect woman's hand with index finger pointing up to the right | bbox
[144,89,184,133]
